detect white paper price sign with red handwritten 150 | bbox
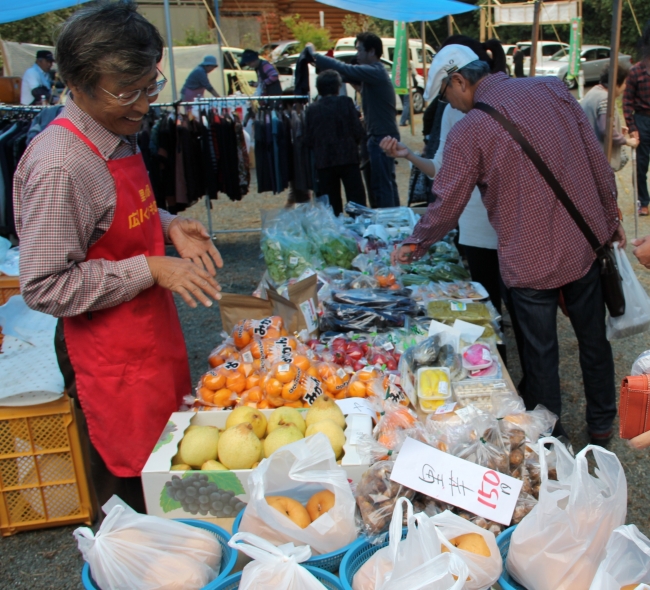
[390,438,523,525]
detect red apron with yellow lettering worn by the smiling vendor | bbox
[51,118,191,477]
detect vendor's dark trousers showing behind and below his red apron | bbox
[54,320,147,521]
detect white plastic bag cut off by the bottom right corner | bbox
[589,524,650,590]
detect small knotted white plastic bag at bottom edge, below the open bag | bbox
[228,533,325,590]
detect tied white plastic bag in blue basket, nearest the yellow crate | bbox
[74,505,221,590]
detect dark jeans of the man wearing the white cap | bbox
[509,263,616,434]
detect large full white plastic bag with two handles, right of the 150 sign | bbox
[506,437,627,590]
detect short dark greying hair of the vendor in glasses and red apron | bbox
[56,0,163,96]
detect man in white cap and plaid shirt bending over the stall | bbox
[393,45,625,444]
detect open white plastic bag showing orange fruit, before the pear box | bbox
[239,432,358,554]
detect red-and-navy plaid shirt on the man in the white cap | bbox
[405,74,619,289]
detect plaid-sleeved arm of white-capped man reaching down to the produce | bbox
[393,128,479,263]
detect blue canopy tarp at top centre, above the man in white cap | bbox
[317,0,476,23]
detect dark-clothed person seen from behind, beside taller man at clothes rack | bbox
[305,70,366,215]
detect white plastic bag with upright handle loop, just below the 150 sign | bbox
[352,498,470,590]
